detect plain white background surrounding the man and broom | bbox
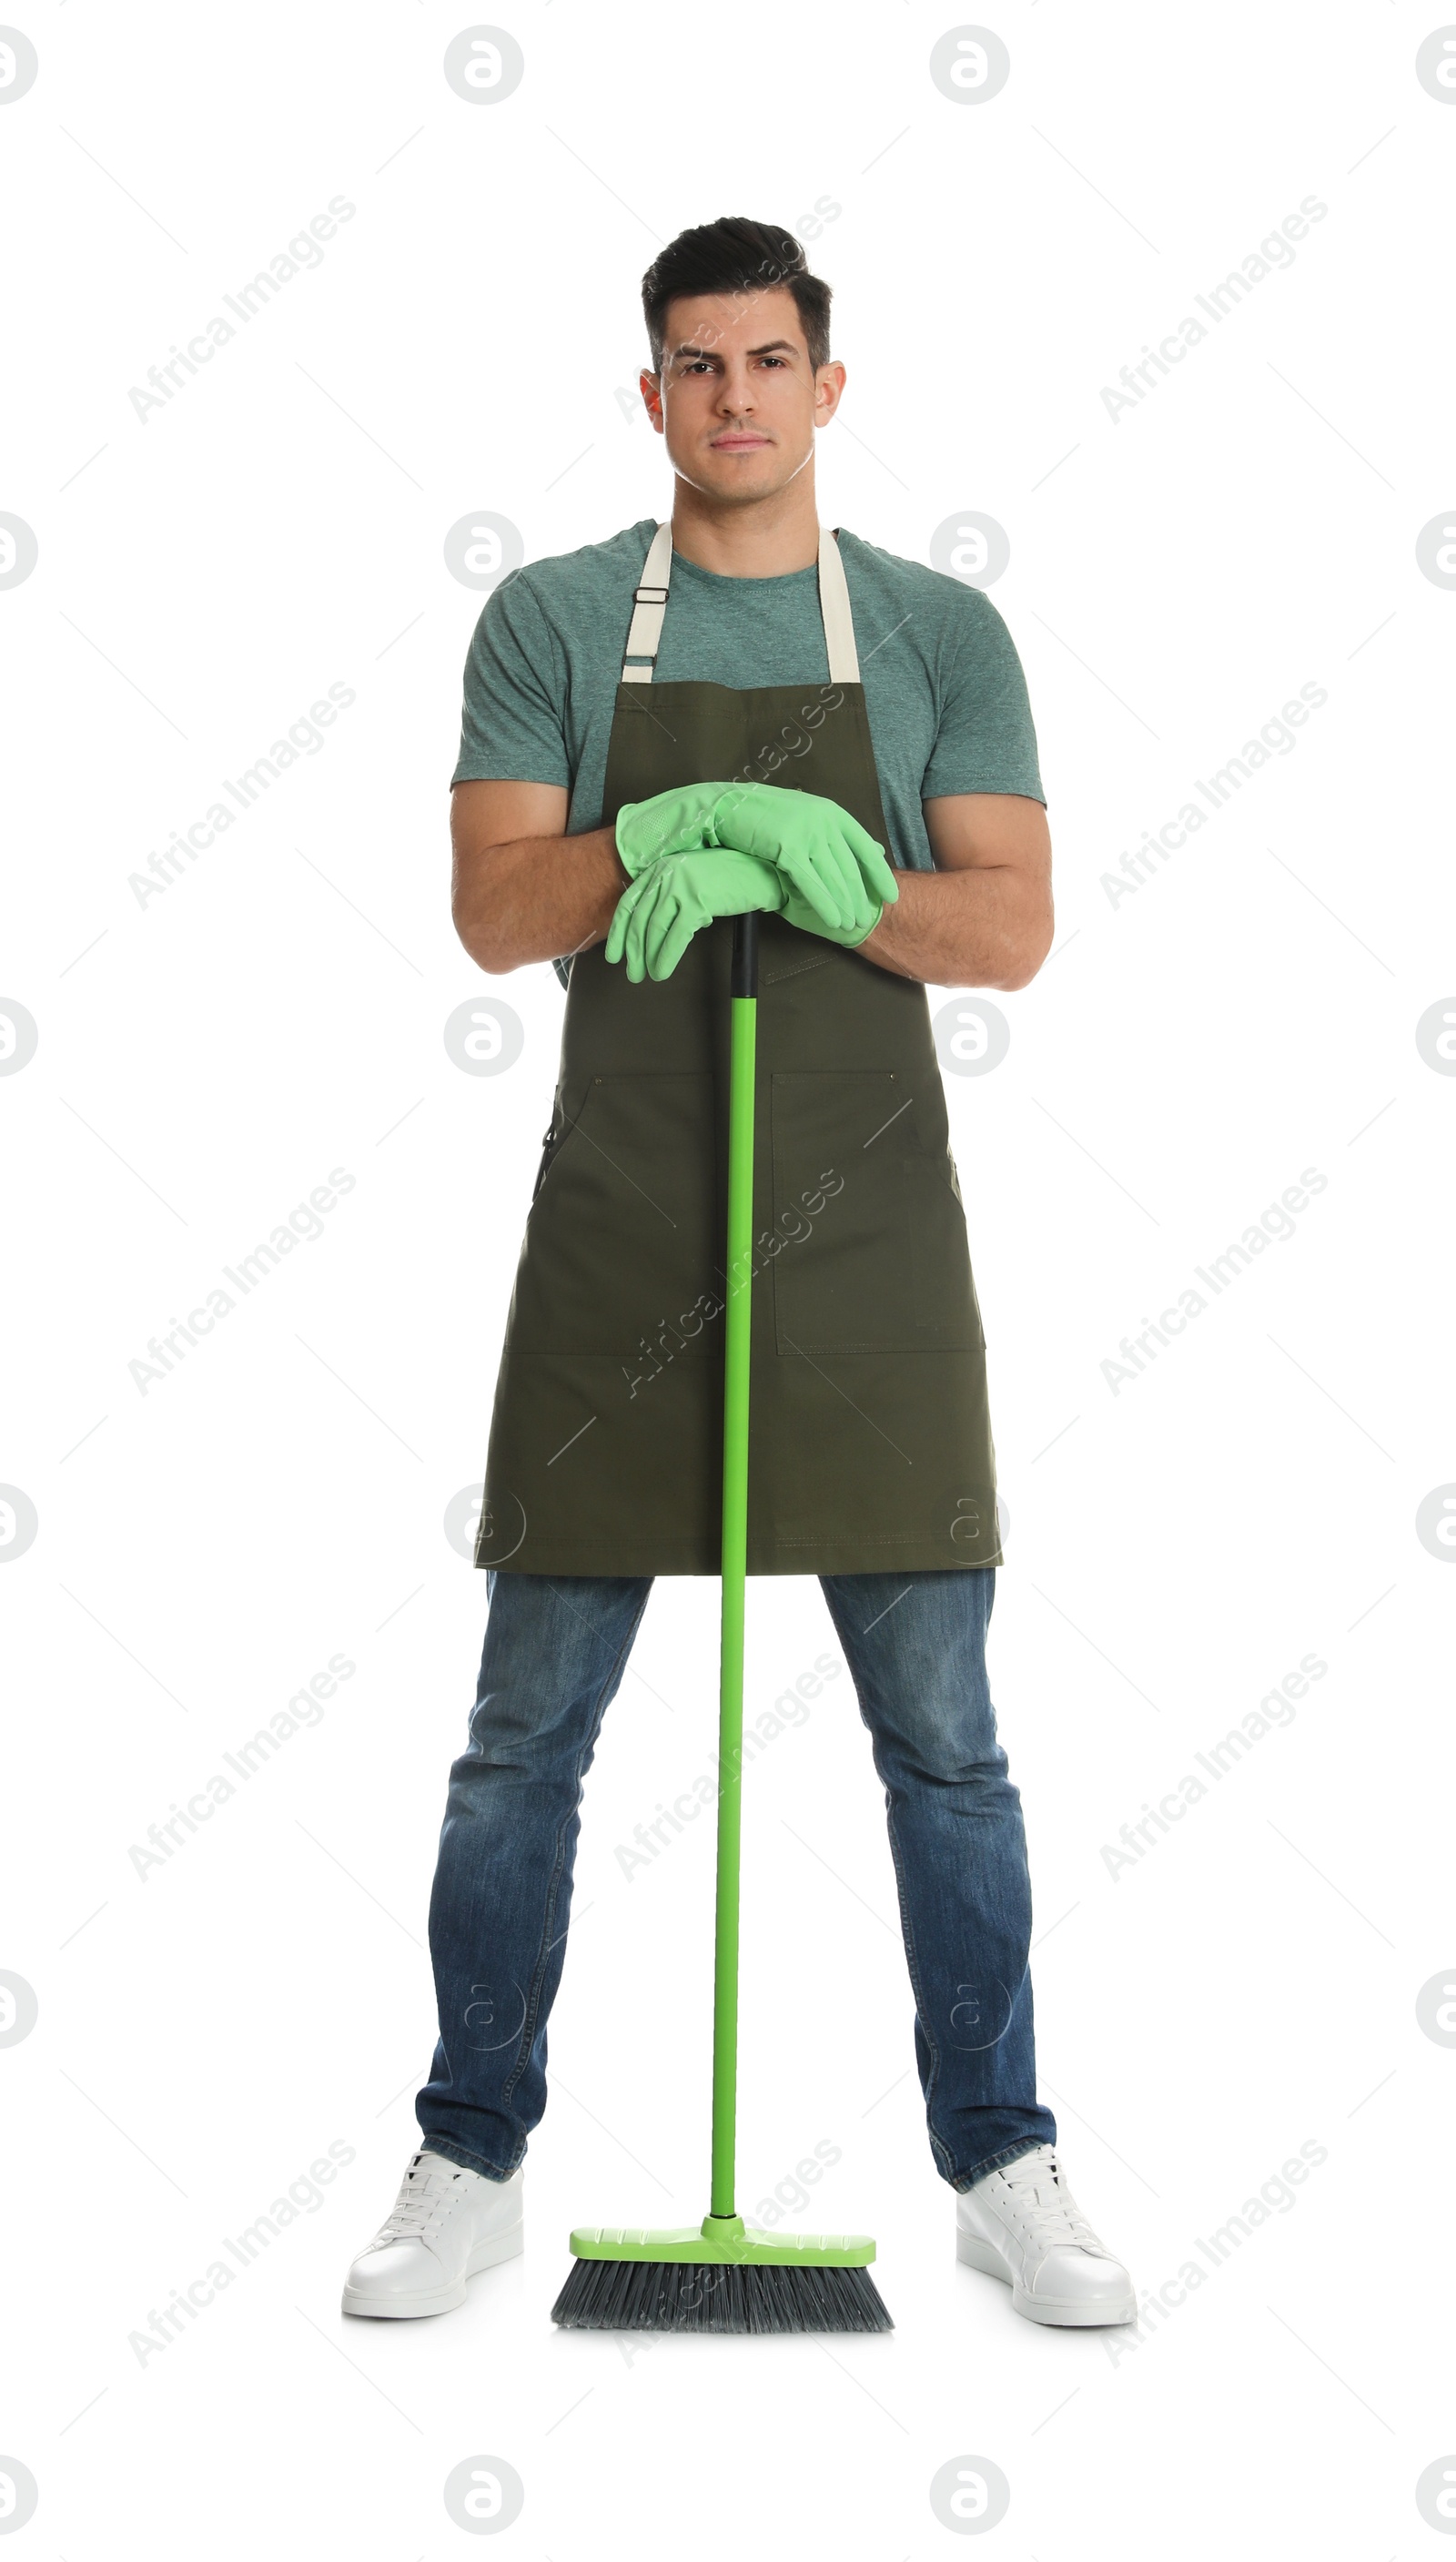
[0,0,1456,2562]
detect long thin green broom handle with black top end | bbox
[710,915,759,2216]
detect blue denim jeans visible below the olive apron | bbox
[415,1565,1057,2188]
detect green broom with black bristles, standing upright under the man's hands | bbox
[551,915,895,2332]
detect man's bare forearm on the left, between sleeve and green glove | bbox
[451,827,628,974]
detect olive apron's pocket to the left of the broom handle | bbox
[508,1071,723,1361]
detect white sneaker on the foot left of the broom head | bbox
[343,2150,525,2321]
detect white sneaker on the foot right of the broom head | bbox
[956,2144,1138,2326]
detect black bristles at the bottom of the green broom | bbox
[551,2260,895,2332]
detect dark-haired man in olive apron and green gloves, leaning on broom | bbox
[343,220,1136,2324]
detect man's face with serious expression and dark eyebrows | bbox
[641,284,844,507]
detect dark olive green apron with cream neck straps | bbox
[474,522,1000,1575]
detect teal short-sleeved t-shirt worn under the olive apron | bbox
[451,515,1046,984]
